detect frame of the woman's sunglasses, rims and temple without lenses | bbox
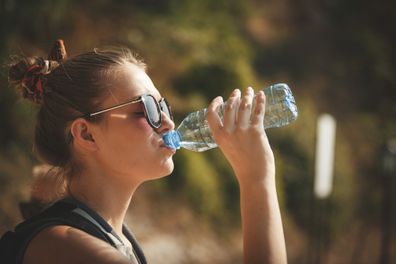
[84,94,173,129]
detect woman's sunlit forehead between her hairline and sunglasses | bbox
[112,63,161,101]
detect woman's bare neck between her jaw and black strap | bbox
[69,166,139,234]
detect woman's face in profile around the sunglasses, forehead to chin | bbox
[95,64,175,185]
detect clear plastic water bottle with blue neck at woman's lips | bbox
[163,83,298,152]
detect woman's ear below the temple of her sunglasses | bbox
[70,118,98,151]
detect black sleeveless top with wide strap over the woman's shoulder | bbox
[0,197,147,264]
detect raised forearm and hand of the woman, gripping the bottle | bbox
[208,88,287,264]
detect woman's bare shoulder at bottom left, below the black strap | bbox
[23,225,130,264]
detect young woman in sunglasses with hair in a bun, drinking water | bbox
[4,42,286,264]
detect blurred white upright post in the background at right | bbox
[314,114,336,199]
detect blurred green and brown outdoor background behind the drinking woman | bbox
[0,0,396,263]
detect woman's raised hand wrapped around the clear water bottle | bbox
[207,87,275,184]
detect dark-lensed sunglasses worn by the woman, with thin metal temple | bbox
[84,94,173,128]
